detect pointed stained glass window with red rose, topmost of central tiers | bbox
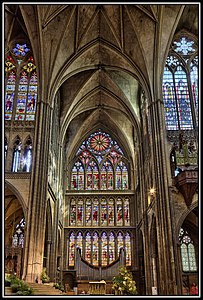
[70,129,129,190]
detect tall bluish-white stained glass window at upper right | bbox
[162,37,198,130]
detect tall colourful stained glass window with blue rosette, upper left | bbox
[5,44,38,121]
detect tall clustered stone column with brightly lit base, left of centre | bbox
[23,101,51,282]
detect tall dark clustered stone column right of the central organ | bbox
[149,99,176,295]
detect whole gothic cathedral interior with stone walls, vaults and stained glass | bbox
[2,2,200,296]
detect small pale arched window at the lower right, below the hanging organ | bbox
[179,228,197,272]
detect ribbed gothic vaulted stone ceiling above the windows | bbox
[5,4,198,158]
